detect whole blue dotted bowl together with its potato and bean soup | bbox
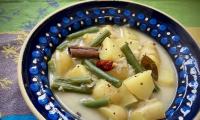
[18,1,200,120]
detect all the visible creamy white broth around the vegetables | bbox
[49,25,177,120]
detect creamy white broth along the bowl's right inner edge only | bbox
[138,32,177,110]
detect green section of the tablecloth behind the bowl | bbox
[0,0,200,32]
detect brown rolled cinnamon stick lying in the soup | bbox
[68,46,99,58]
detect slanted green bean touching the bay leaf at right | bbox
[121,43,144,73]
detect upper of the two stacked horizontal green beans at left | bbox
[54,77,92,85]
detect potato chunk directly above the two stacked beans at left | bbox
[65,64,91,78]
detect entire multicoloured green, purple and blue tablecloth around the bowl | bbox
[0,0,200,120]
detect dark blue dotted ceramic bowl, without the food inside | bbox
[18,1,200,120]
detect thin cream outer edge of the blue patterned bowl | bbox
[17,0,199,120]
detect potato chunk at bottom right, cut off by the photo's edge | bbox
[131,99,165,120]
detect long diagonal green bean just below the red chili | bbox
[83,59,122,88]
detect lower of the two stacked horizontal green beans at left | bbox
[51,82,92,94]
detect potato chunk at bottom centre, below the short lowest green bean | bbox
[99,105,128,120]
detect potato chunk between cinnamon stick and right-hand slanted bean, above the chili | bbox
[99,38,122,61]
